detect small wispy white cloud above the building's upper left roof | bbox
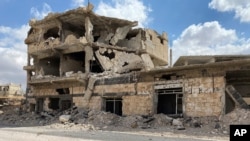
[30,3,52,19]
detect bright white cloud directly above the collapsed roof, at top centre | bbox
[96,0,152,27]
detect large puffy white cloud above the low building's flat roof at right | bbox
[172,21,250,61]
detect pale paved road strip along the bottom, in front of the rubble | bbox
[0,127,225,141]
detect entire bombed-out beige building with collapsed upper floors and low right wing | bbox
[24,4,250,116]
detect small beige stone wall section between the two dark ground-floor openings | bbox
[122,95,153,116]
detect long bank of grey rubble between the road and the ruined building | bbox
[0,106,250,136]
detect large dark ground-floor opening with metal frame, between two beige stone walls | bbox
[156,88,183,114]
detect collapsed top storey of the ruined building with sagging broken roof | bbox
[25,4,168,66]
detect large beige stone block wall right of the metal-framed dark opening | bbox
[183,77,225,117]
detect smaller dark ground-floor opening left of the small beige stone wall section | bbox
[106,98,122,116]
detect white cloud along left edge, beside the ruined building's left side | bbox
[0,25,29,88]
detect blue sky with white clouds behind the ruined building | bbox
[0,0,250,88]
